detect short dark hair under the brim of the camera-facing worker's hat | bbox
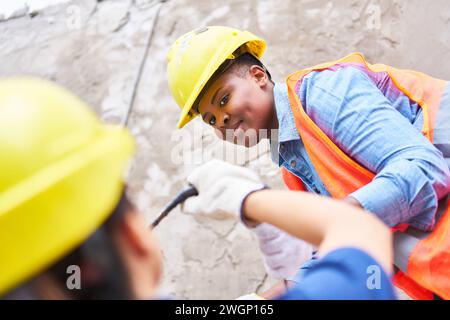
[194,49,273,113]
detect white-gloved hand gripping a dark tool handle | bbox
[181,160,266,222]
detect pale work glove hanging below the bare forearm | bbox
[254,223,313,279]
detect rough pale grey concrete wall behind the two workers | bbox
[0,0,450,299]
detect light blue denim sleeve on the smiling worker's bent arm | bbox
[299,67,450,230]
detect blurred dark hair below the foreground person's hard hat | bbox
[4,192,133,300]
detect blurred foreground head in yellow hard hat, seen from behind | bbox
[0,78,161,299]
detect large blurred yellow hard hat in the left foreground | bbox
[0,78,134,295]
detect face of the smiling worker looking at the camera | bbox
[198,65,276,147]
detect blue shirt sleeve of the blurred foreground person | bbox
[280,248,395,300]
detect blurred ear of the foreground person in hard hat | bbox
[120,211,153,255]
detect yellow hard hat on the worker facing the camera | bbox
[167,26,266,128]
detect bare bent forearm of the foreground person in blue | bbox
[244,190,392,270]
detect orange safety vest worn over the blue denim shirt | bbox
[282,53,450,299]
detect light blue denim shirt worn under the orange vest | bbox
[271,66,450,230]
